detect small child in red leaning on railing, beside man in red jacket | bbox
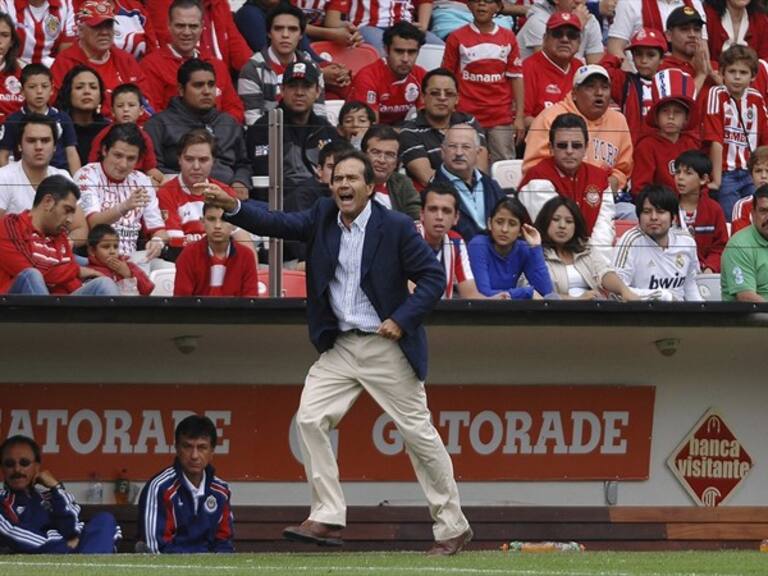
[88,224,155,296]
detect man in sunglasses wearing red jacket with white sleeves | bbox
[518,113,616,264]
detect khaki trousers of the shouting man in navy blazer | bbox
[296,332,469,540]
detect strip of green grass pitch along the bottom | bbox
[0,552,768,576]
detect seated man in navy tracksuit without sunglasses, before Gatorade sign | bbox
[137,414,234,553]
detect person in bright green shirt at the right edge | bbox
[720,184,768,302]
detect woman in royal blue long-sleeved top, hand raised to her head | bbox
[468,197,552,300]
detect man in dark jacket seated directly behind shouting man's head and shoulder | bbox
[360,124,421,220]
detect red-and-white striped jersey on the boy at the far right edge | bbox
[702,86,768,172]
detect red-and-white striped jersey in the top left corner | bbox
[0,0,76,68]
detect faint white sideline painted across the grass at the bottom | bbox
[0,560,740,576]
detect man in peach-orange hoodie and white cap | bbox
[523,64,633,194]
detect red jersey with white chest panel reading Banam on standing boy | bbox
[443,24,523,128]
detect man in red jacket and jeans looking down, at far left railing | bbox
[0,174,119,296]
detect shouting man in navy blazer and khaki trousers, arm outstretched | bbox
[205,151,472,555]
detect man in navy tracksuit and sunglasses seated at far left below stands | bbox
[0,435,121,554]
